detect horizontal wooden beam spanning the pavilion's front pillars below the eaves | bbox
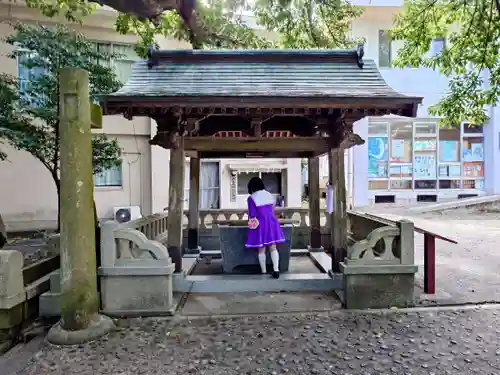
[184,137,328,153]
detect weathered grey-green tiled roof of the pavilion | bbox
[103,50,421,103]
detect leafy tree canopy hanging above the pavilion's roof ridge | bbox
[18,0,362,53]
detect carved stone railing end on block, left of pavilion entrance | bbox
[99,213,175,316]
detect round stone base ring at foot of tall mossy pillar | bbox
[47,315,115,345]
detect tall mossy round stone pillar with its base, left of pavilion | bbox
[47,69,114,345]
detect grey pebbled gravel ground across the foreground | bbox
[18,309,500,375]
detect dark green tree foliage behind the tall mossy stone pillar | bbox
[0,24,121,178]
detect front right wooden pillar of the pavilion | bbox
[328,149,347,272]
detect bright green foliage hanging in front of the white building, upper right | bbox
[391,0,500,127]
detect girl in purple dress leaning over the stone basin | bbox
[245,177,285,279]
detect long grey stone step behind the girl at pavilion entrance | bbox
[174,273,343,293]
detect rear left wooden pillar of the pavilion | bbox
[188,156,200,254]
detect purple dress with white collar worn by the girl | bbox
[245,190,285,249]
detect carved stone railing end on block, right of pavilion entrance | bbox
[340,212,418,309]
